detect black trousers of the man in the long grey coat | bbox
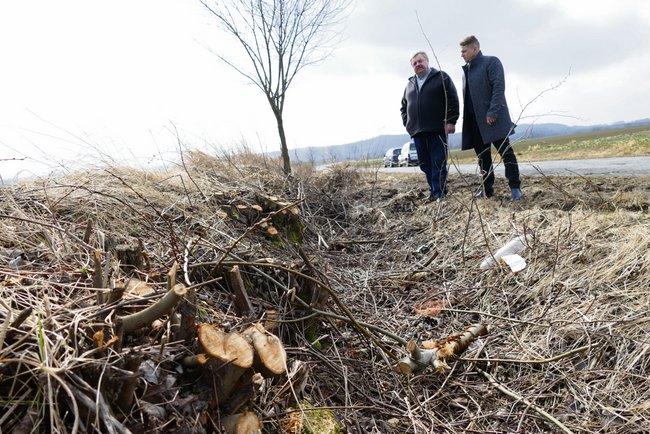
[463,114,521,196]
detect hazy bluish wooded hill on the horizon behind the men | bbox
[268,118,650,164]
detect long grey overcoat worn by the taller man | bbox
[462,51,515,149]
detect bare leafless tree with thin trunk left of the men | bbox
[199,0,352,174]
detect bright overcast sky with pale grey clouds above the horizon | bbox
[0,0,650,180]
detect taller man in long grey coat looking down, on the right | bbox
[460,35,522,200]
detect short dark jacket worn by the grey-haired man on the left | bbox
[400,68,460,137]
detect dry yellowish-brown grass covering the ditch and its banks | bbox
[0,153,650,433]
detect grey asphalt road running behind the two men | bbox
[380,157,650,177]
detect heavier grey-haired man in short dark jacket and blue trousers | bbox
[400,51,460,201]
